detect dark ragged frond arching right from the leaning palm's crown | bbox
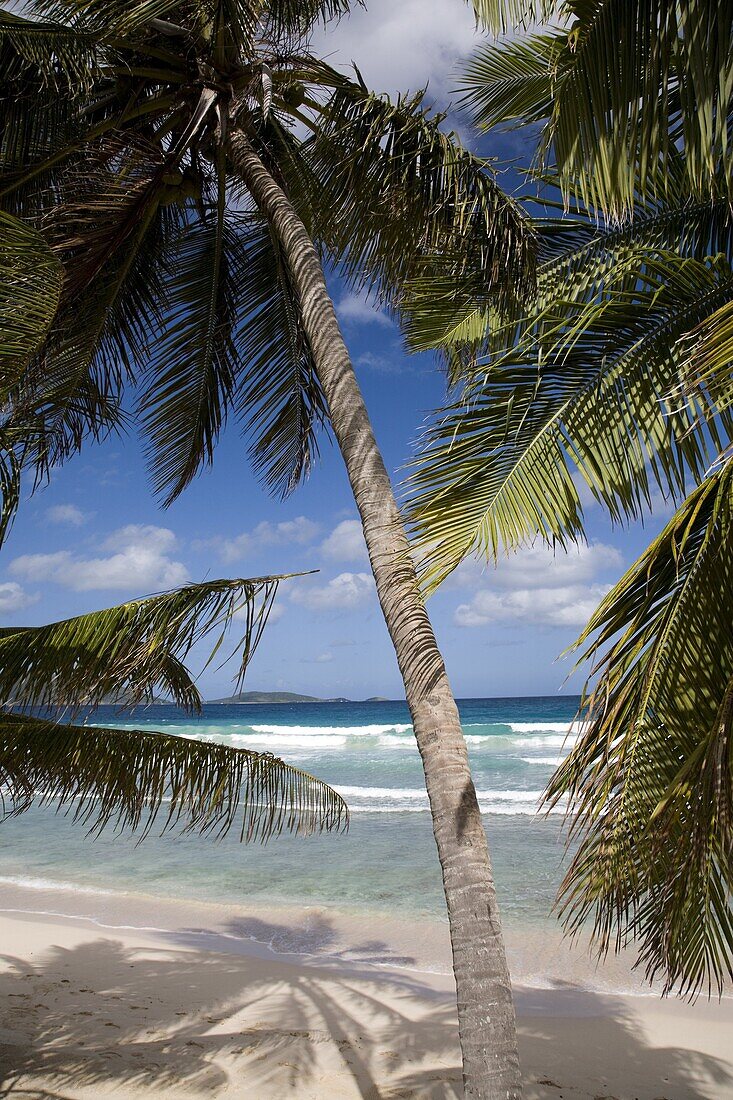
[304,61,535,308]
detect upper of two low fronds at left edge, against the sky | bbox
[0,576,284,711]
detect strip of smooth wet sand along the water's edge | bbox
[0,876,733,998]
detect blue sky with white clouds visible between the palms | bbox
[0,0,668,699]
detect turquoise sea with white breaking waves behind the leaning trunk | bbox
[0,696,578,924]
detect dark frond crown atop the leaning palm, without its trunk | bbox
[0,2,533,536]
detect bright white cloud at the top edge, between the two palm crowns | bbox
[305,0,478,97]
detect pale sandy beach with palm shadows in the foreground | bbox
[0,888,733,1100]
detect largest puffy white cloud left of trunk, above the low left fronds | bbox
[9,524,188,593]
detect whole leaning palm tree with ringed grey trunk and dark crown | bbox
[0,0,534,1100]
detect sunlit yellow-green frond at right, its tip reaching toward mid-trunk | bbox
[408,250,733,585]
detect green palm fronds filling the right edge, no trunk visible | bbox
[405,0,733,994]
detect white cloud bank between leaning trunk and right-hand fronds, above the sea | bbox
[453,542,623,627]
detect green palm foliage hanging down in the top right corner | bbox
[466,0,733,218]
